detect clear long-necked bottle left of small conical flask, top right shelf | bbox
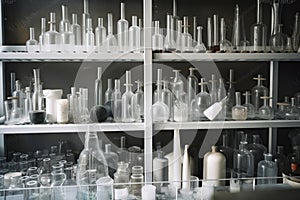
[181,16,194,53]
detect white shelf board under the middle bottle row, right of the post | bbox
[154,120,300,130]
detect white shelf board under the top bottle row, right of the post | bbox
[153,53,300,62]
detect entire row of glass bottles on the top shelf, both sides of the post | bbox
[26,0,300,52]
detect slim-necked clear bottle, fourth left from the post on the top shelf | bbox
[106,13,118,53]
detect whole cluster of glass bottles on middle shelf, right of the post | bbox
[152,68,300,122]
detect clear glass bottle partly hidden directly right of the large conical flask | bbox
[104,144,119,178]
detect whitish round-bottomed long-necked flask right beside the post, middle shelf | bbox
[152,69,170,122]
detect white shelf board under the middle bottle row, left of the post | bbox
[0,123,144,134]
